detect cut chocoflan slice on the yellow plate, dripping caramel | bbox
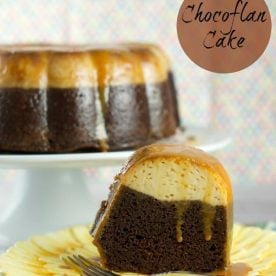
[91,145,232,274]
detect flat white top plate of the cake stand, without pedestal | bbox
[0,128,231,169]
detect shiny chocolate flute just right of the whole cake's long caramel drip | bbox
[105,85,152,149]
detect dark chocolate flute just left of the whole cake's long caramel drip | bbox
[47,88,99,152]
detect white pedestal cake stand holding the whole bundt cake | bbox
[0,128,231,248]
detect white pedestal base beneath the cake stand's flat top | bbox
[0,168,108,248]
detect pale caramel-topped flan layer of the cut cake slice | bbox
[116,144,232,205]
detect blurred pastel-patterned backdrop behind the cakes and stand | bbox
[0,0,276,223]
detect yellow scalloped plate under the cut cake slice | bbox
[0,225,276,276]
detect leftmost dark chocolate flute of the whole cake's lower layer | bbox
[0,88,48,152]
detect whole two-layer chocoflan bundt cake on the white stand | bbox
[0,43,179,152]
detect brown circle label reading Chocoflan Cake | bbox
[177,0,272,73]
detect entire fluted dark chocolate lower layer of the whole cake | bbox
[0,79,176,152]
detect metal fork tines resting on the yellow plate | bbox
[63,255,119,276]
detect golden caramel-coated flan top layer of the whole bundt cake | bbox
[0,44,170,88]
